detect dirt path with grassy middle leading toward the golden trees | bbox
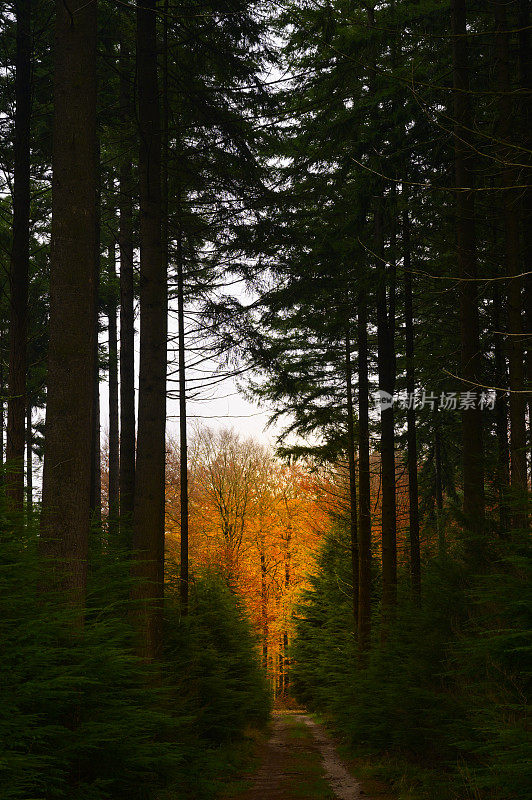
[225,711,393,800]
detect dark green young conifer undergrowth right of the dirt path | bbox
[292,520,532,800]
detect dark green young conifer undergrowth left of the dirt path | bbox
[0,518,269,800]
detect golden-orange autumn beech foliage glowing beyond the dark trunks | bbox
[102,428,444,680]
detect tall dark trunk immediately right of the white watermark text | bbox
[492,0,528,527]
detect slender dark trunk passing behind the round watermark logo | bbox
[375,198,397,618]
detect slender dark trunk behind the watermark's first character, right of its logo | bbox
[403,208,421,605]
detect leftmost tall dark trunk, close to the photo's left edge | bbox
[6,0,32,512]
